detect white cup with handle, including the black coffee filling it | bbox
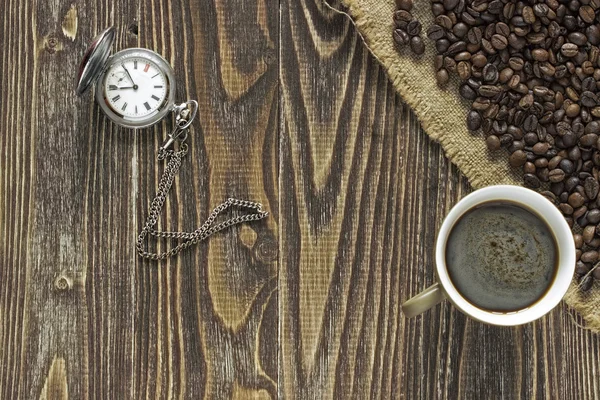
[402,185,575,326]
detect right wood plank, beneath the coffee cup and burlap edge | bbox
[280,1,600,399]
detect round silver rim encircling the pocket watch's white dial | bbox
[96,47,175,128]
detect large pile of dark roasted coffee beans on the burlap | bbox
[427,0,600,291]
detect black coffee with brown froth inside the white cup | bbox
[446,202,558,312]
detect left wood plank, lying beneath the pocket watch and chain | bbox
[0,0,278,399]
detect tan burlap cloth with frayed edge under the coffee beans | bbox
[332,0,600,332]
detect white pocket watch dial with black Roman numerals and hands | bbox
[104,57,169,118]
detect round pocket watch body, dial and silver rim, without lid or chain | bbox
[97,49,174,128]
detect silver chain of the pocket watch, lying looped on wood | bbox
[136,108,269,260]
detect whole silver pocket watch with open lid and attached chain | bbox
[76,27,268,260]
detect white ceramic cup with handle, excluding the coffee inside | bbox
[402,185,575,326]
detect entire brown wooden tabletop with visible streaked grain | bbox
[0,0,600,400]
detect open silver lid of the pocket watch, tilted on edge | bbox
[76,26,115,95]
